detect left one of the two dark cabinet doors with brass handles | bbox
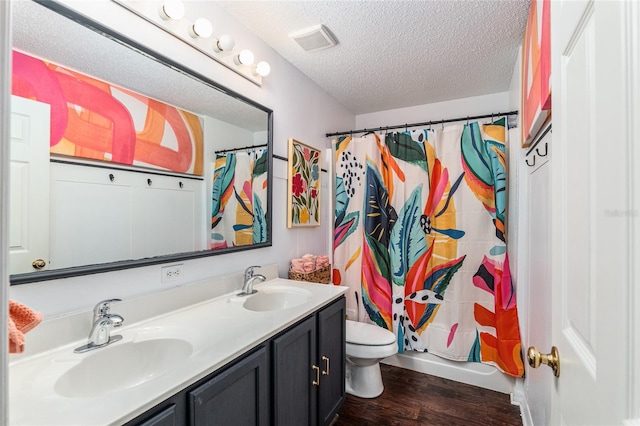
[273,316,320,426]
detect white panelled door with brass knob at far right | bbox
[548,1,638,425]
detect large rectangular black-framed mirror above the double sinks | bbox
[10,1,272,284]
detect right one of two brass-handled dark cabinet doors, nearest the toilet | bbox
[318,298,346,425]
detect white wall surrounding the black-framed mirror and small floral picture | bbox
[2,0,355,318]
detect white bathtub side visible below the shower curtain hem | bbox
[381,351,515,394]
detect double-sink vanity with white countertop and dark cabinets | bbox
[9,264,346,425]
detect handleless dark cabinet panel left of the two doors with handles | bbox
[189,347,270,426]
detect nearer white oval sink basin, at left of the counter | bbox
[55,338,193,398]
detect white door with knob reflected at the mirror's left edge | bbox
[9,96,50,274]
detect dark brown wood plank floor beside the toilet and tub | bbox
[333,364,522,426]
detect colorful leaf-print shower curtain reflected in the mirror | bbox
[210,149,268,249]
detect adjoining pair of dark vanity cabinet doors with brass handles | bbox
[272,298,345,426]
